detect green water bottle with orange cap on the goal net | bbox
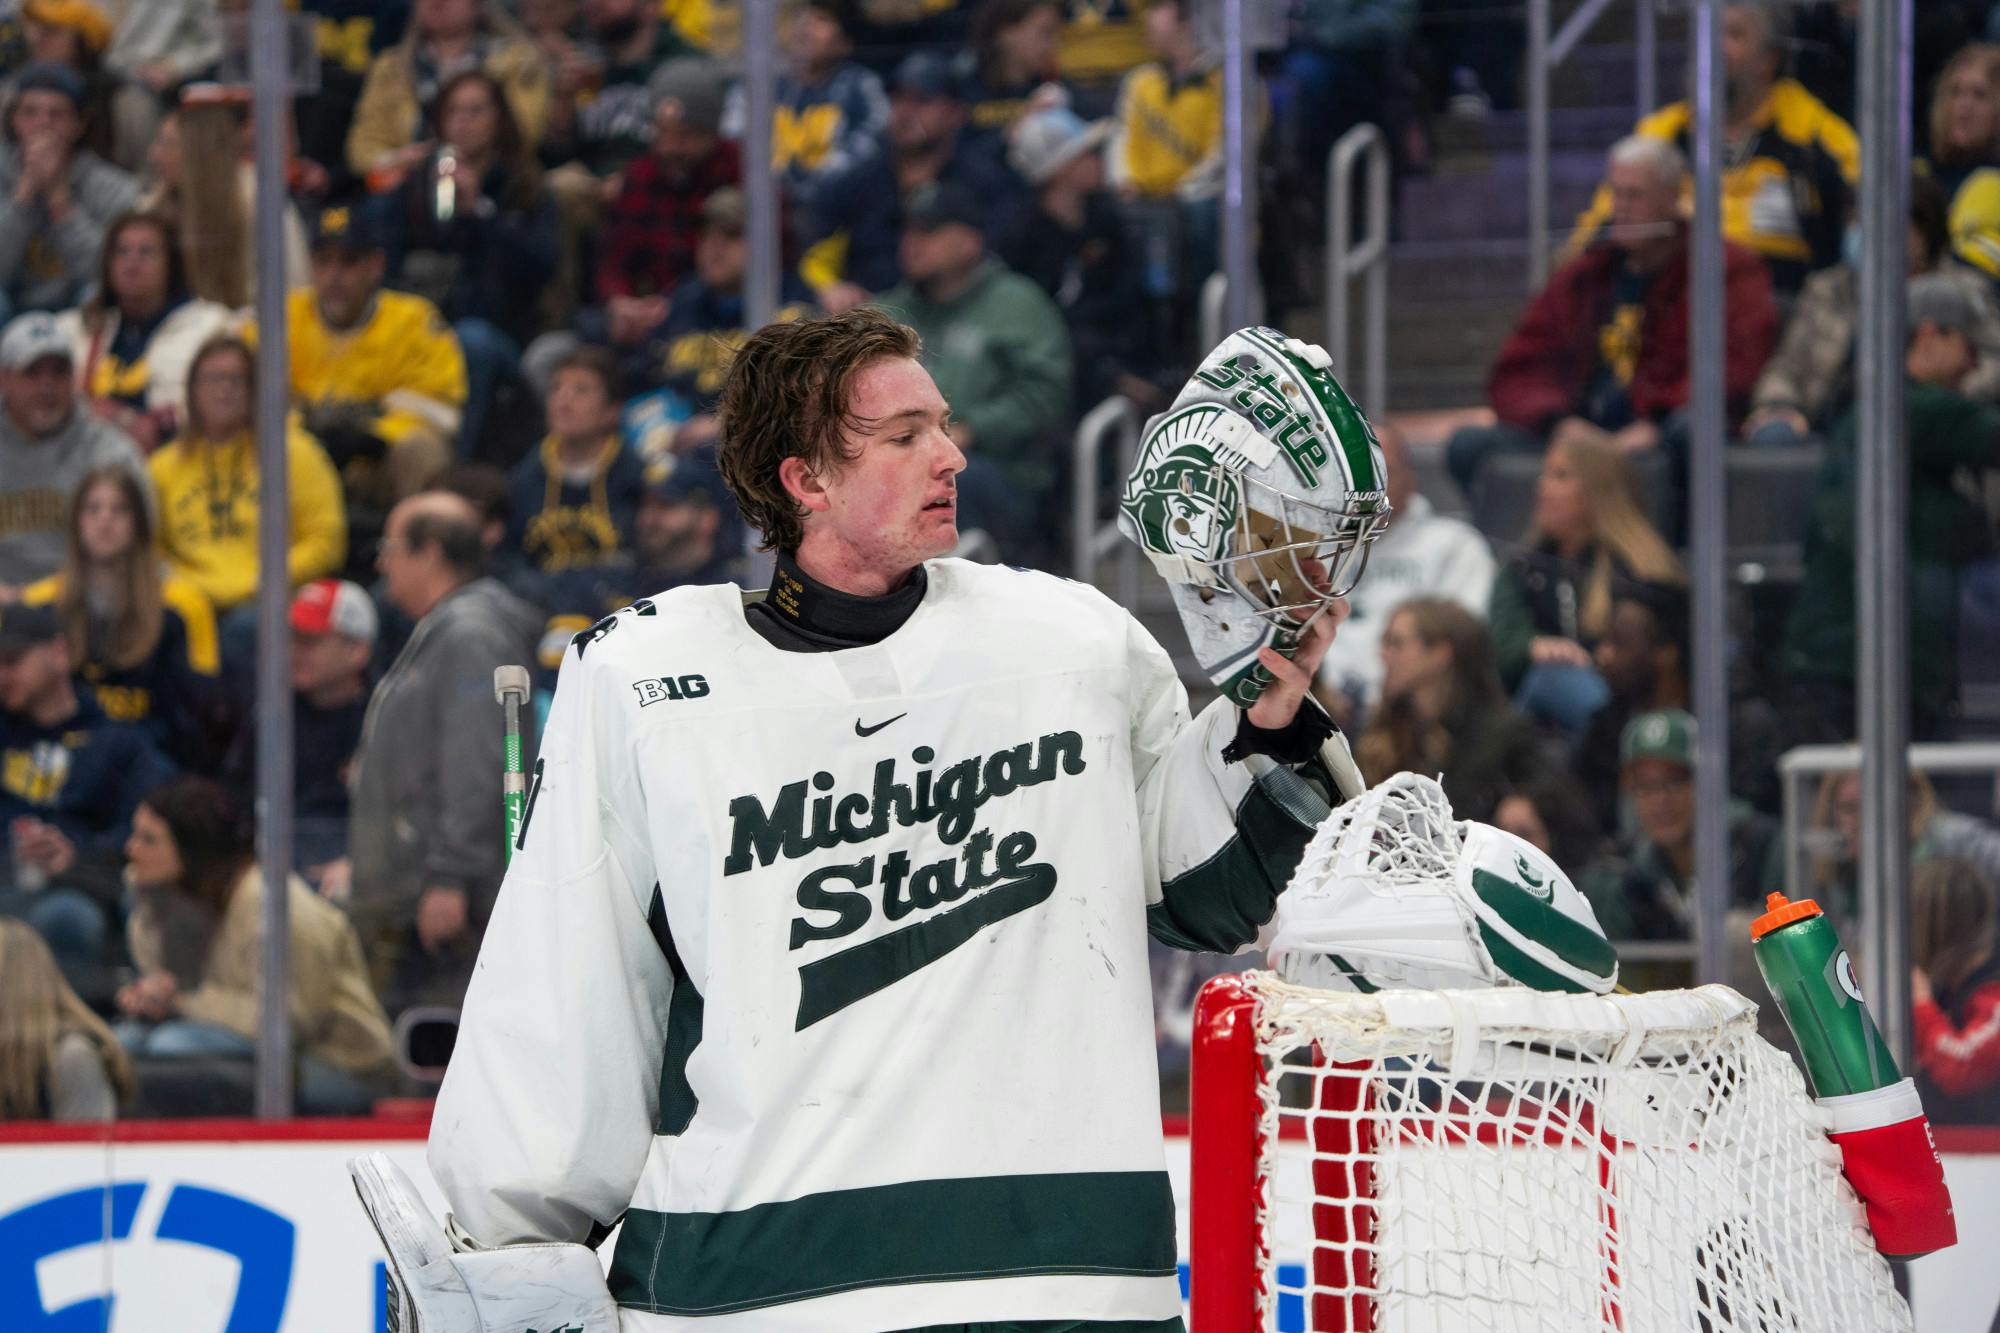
[1750,893,1902,1097]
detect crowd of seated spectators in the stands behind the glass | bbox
[0,0,2000,1119]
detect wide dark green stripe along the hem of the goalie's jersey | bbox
[610,1171,1176,1315]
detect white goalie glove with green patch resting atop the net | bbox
[1270,773,1618,995]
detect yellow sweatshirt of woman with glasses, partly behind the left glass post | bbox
[146,428,348,612]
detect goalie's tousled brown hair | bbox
[716,306,924,552]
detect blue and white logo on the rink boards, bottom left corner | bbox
[0,1181,296,1333]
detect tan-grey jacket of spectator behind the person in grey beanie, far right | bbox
[1750,260,2000,430]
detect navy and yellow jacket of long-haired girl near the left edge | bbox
[20,574,222,767]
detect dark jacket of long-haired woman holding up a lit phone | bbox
[380,154,560,346]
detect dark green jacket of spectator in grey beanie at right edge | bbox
[1784,384,2000,715]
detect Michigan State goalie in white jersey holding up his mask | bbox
[354,310,1408,1333]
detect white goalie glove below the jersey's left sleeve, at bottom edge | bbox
[348,1153,618,1333]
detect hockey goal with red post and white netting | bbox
[1190,973,1910,1333]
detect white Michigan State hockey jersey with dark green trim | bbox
[430,560,1312,1331]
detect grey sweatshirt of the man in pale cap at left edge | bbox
[0,398,152,586]
